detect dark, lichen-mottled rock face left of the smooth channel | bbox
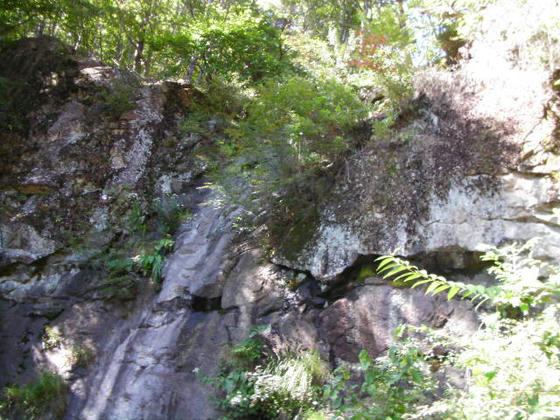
[0,38,209,398]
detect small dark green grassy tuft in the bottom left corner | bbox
[0,372,67,420]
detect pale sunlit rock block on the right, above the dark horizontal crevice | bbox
[275,55,560,281]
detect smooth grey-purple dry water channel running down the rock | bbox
[75,194,236,419]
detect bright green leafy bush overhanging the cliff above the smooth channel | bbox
[217,76,365,212]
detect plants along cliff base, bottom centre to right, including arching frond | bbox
[206,241,560,420]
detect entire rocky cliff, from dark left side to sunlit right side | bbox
[0,39,560,420]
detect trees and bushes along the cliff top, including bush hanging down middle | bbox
[6,0,560,254]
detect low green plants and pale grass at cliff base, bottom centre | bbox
[205,324,435,419]
